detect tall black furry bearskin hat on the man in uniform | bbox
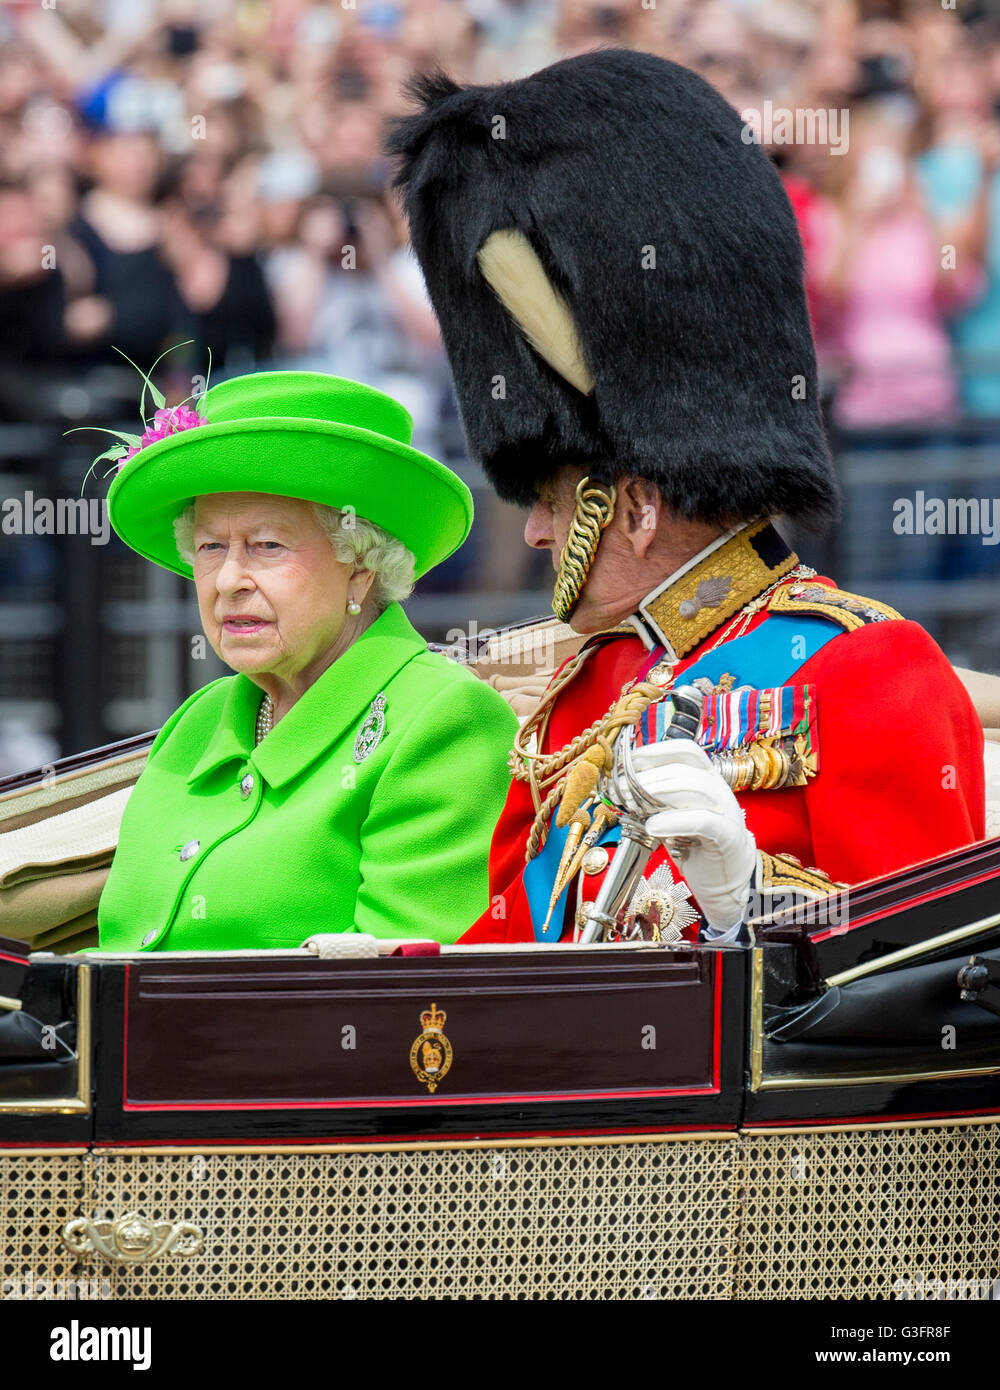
[387,50,837,523]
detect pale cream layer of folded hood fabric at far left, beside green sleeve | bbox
[0,787,132,892]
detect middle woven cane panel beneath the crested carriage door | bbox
[87,1141,737,1300]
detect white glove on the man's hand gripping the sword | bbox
[631,738,757,937]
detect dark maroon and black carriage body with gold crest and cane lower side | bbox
[0,733,1000,1300]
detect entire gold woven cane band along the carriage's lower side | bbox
[7,1122,1000,1301]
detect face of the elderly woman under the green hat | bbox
[193,492,370,681]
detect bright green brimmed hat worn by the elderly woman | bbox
[107,371,473,578]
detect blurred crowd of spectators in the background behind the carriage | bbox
[0,0,1000,439]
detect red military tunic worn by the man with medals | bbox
[460,567,985,942]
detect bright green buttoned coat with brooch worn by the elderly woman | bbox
[99,603,517,951]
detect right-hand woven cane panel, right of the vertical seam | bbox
[734,1123,1000,1298]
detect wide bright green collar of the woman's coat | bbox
[188,603,427,787]
